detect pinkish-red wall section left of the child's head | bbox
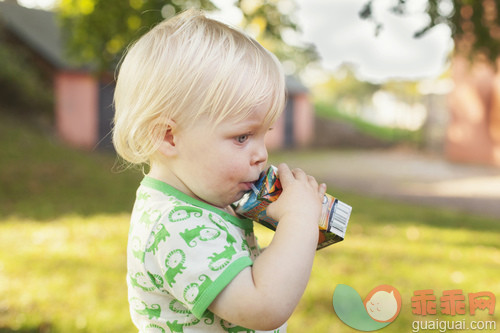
[54,71,99,149]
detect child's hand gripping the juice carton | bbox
[267,163,326,226]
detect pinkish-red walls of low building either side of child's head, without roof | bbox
[54,71,314,150]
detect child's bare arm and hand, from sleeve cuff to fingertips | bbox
[209,164,326,331]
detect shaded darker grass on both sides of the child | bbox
[0,112,500,237]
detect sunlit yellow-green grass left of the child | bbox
[0,214,134,332]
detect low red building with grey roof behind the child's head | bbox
[0,1,314,150]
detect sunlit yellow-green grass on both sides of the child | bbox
[0,195,500,332]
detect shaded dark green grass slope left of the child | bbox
[0,113,142,221]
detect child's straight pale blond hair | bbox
[113,10,285,164]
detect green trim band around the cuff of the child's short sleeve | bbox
[192,257,253,319]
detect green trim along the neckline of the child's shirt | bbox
[141,176,253,231]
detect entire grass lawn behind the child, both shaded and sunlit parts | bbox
[0,114,500,332]
